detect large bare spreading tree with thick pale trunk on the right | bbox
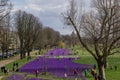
[64,0,120,80]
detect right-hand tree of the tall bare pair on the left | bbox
[25,14,42,56]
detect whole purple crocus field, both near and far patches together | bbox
[8,49,92,80]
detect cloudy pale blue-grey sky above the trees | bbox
[10,0,90,35]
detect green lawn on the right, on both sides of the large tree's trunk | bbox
[73,46,120,80]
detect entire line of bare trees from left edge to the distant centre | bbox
[0,0,77,59]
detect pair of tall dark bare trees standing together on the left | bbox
[15,11,42,59]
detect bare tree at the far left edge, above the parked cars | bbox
[0,0,12,56]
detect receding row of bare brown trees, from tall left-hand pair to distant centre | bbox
[14,11,77,59]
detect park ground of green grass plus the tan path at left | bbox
[0,47,120,80]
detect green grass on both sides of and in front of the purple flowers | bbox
[2,48,120,80]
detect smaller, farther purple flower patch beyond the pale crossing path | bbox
[45,48,71,56]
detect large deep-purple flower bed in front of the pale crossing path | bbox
[20,57,91,80]
